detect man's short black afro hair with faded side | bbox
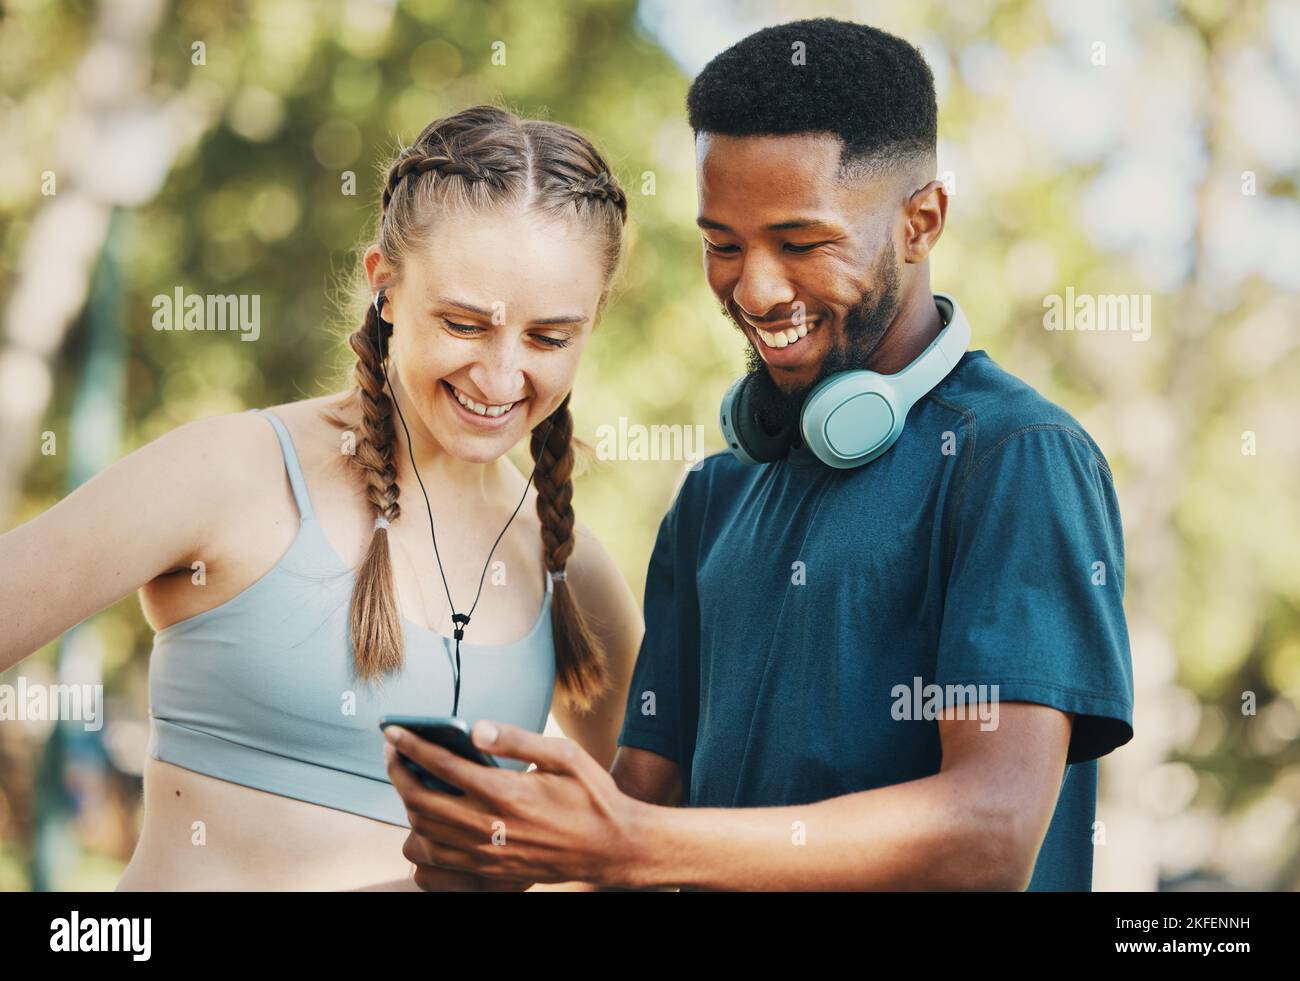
[686,17,939,173]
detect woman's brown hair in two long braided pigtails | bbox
[330,105,628,711]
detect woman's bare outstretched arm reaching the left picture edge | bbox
[0,413,256,670]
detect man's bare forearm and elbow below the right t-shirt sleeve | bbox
[620,703,1071,890]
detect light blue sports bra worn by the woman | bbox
[150,409,555,828]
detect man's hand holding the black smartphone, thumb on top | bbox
[385,721,649,887]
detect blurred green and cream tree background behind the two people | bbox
[0,0,1300,890]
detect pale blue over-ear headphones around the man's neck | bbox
[719,292,971,470]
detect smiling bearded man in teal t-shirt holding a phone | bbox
[389,19,1132,890]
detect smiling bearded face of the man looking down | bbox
[696,133,909,430]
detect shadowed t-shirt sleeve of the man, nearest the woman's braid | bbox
[619,477,699,767]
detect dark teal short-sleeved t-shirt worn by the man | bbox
[619,351,1132,890]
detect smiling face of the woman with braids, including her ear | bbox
[365,209,605,463]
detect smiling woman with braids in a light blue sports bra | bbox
[0,107,642,890]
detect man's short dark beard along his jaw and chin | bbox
[745,242,900,434]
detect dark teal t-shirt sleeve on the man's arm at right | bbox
[935,425,1134,763]
